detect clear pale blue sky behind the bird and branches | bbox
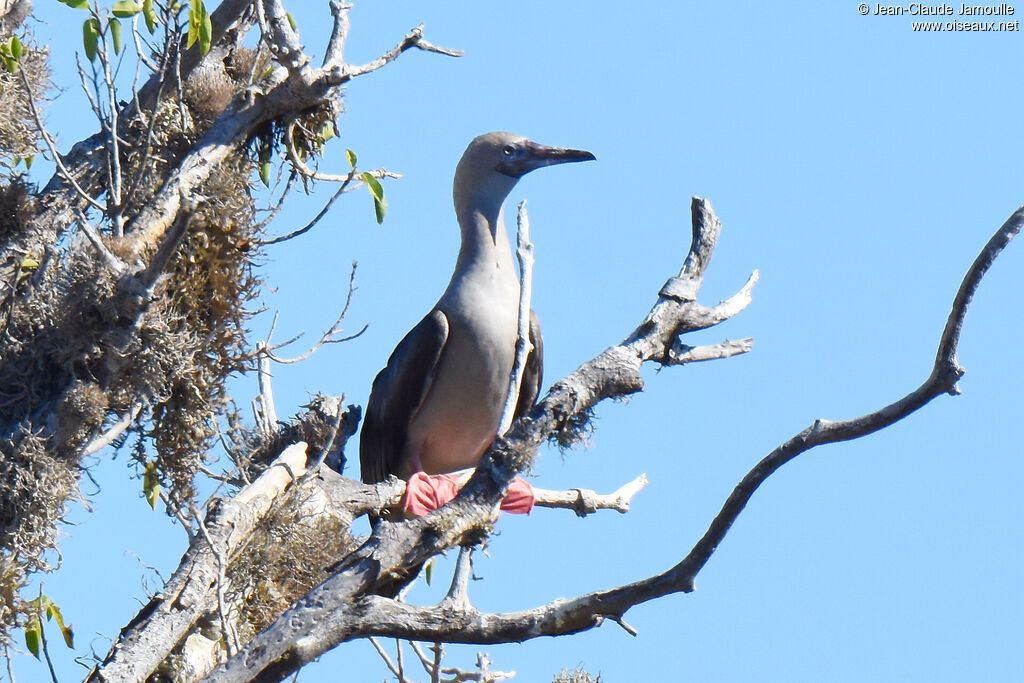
[15,0,1024,683]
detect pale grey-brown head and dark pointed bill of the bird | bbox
[455,133,595,220]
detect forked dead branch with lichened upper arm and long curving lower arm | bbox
[208,199,1024,682]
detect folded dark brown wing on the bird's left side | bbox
[359,310,449,483]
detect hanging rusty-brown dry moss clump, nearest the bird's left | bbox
[126,152,260,505]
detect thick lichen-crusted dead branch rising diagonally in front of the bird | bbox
[207,194,750,683]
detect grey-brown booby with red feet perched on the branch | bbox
[359,133,594,515]
